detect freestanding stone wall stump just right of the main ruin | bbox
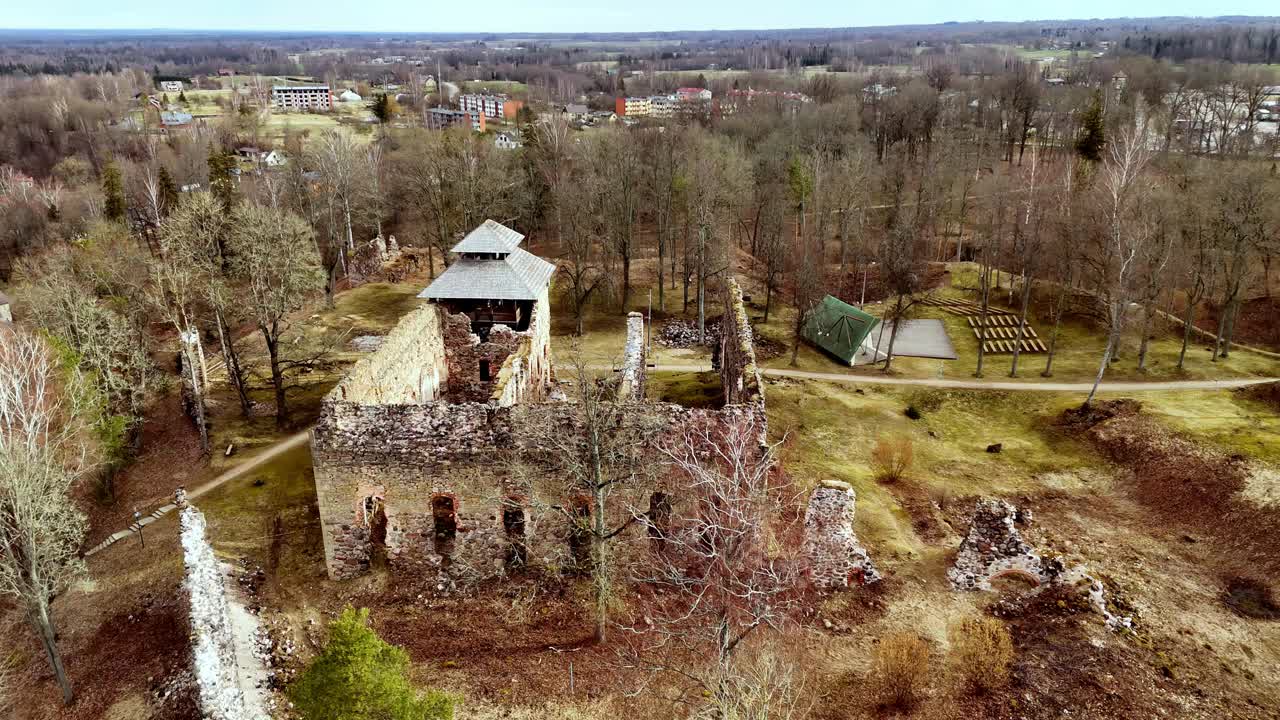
[804,480,881,589]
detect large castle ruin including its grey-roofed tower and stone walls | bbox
[311,220,765,580]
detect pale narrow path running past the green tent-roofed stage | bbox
[616,365,1280,392]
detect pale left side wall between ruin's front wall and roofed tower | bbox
[330,305,447,405]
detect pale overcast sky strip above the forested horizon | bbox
[0,0,1280,33]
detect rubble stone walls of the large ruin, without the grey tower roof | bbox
[312,278,764,582]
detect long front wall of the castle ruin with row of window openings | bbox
[312,394,763,580]
